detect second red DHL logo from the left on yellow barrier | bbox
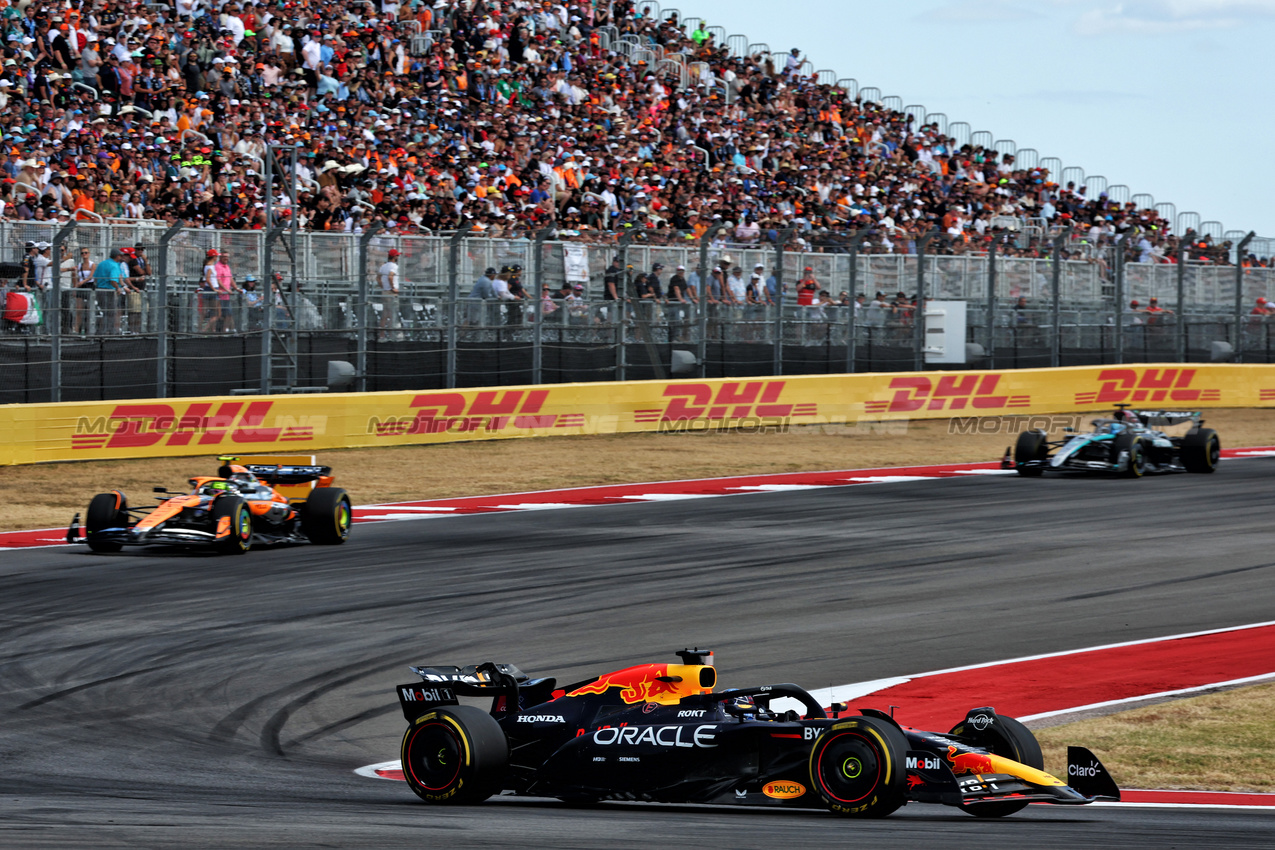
[367,390,584,437]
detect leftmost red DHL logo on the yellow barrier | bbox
[71,401,318,450]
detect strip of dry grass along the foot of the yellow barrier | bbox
[0,409,1275,530]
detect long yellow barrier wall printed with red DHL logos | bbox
[0,363,1275,465]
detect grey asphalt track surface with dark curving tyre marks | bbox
[0,460,1275,847]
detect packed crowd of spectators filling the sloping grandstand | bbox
[0,0,1259,263]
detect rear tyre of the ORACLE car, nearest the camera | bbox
[400,706,509,805]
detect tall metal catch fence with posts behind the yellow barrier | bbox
[0,222,1275,403]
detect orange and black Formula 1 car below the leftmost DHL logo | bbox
[66,456,351,554]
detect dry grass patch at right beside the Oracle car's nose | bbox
[1037,684,1275,793]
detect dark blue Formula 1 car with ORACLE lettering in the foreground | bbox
[398,650,1119,817]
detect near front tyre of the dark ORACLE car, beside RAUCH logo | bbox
[810,717,908,818]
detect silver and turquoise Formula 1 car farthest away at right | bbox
[1001,404,1221,478]
